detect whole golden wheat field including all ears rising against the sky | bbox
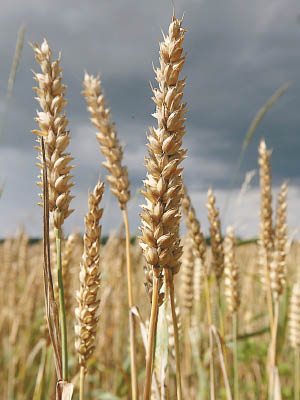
[0,15,300,400]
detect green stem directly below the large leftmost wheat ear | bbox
[55,228,68,381]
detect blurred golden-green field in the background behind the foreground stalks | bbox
[0,230,300,400]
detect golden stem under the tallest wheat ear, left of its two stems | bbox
[143,275,159,400]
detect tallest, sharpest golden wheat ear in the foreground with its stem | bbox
[140,16,186,400]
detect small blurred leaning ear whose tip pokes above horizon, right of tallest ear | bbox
[206,189,224,284]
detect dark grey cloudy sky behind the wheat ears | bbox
[0,0,300,237]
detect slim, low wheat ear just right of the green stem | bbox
[75,181,104,368]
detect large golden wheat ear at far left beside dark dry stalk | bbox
[32,39,74,230]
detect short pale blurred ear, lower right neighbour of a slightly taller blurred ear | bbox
[224,226,240,314]
